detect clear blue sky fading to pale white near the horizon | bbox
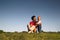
[0,0,60,32]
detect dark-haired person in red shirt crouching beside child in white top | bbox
[27,16,36,33]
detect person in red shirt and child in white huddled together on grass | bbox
[27,16,42,33]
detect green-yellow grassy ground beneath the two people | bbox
[0,32,60,40]
